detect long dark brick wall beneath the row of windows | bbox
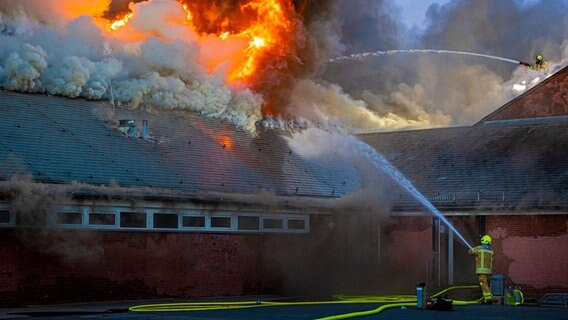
[0,215,377,306]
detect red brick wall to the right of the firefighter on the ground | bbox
[486,215,568,298]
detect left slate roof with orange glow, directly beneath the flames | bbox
[0,91,358,205]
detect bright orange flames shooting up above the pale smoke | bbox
[106,0,294,84]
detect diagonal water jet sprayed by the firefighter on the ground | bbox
[350,136,472,249]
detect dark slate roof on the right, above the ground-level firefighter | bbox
[359,112,568,209]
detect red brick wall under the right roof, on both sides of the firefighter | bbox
[382,214,568,299]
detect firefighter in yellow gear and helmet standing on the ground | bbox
[468,234,493,304]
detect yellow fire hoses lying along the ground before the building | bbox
[128,285,482,320]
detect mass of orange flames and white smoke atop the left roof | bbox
[0,0,326,131]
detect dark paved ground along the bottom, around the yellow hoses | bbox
[0,298,568,320]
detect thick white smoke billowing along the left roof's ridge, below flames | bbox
[0,0,263,132]
